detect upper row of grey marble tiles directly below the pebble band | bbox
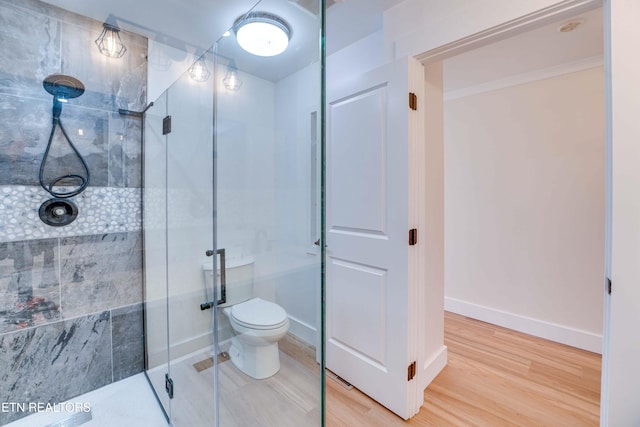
[0,232,142,334]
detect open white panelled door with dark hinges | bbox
[326,59,423,419]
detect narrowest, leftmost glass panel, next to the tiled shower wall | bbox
[143,89,170,415]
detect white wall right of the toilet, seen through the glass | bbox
[275,63,321,346]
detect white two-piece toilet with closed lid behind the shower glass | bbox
[202,258,289,380]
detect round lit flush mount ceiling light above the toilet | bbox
[233,12,291,56]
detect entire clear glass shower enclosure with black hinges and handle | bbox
[143,0,324,426]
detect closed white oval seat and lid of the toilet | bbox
[230,298,288,330]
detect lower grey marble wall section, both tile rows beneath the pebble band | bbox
[0,232,144,425]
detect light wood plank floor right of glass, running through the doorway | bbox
[326,313,601,427]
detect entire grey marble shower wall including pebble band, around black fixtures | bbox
[0,0,147,425]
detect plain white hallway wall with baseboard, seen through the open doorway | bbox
[445,67,605,352]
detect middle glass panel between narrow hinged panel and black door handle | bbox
[166,49,215,426]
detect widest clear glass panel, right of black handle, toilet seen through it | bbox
[215,0,322,426]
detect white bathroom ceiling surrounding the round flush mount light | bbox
[43,0,402,81]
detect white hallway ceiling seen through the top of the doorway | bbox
[443,8,604,93]
